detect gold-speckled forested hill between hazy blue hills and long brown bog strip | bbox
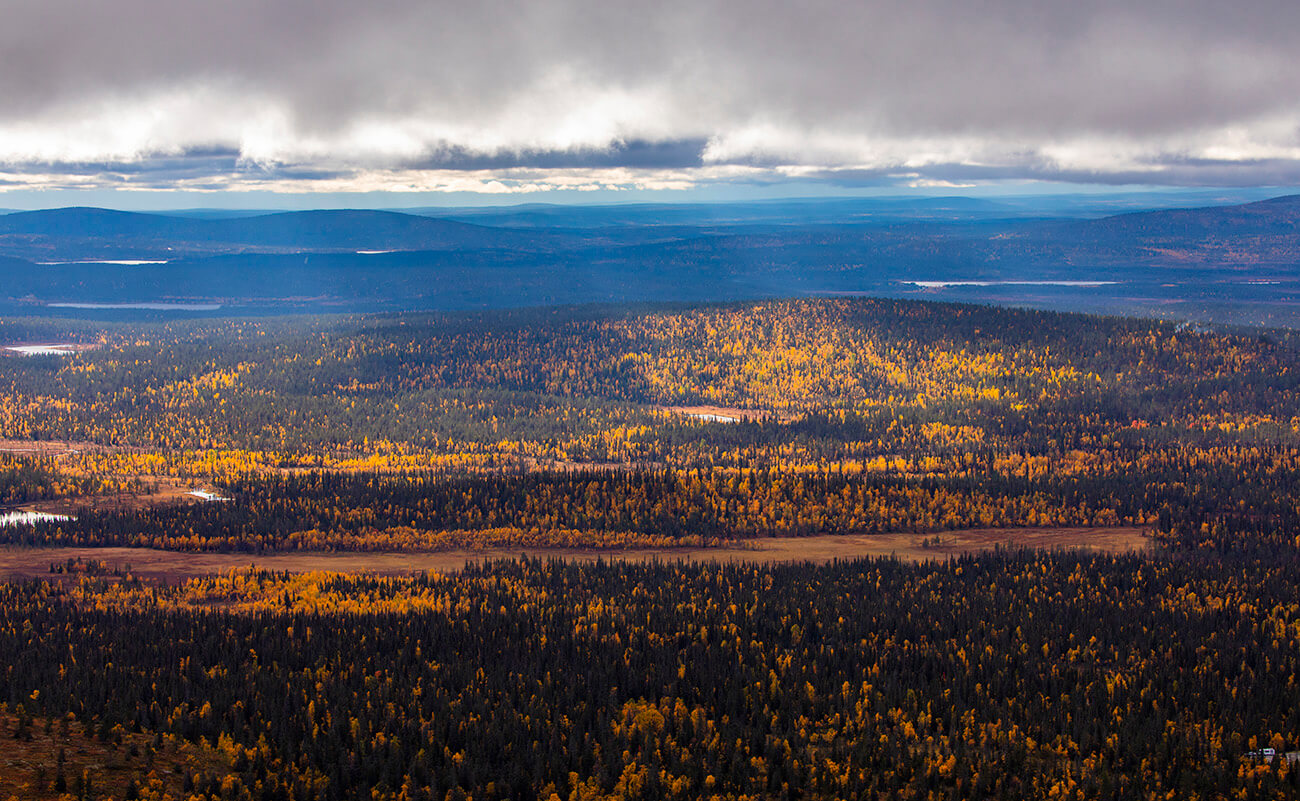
[0,299,1300,550]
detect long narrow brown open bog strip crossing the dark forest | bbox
[0,527,1151,580]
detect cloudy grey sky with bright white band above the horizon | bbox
[0,0,1300,208]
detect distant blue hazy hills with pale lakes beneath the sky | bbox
[0,195,1300,325]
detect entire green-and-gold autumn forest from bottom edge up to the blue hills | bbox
[0,298,1300,801]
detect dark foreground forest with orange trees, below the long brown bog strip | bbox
[0,551,1300,801]
